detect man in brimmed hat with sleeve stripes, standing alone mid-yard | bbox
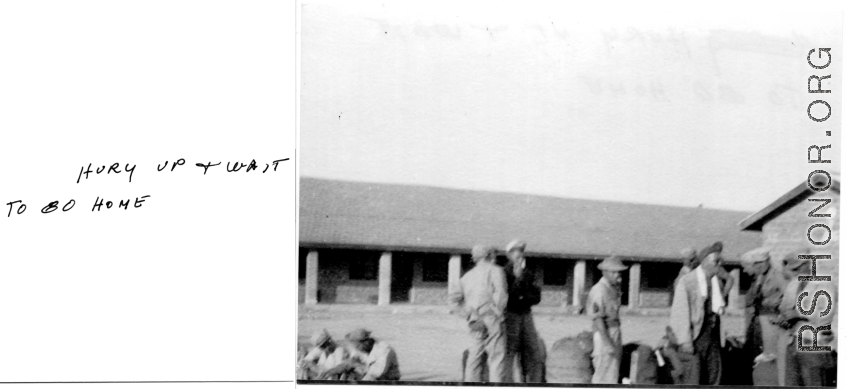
[586,256,627,384]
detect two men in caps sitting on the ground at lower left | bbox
[297,328,400,381]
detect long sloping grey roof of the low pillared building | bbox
[299,177,761,262]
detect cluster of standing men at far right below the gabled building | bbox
[742,244,838,386]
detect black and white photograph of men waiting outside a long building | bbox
[296,1,844,387]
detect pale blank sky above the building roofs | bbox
[298,2,843,212]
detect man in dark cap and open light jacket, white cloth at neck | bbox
[670,242,724,385]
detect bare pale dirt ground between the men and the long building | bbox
[298,305,744,381]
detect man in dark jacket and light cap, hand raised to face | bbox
[505,240,545,382]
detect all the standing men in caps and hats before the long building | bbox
[448,240,837,386]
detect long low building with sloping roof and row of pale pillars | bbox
[299,178,762,308]
